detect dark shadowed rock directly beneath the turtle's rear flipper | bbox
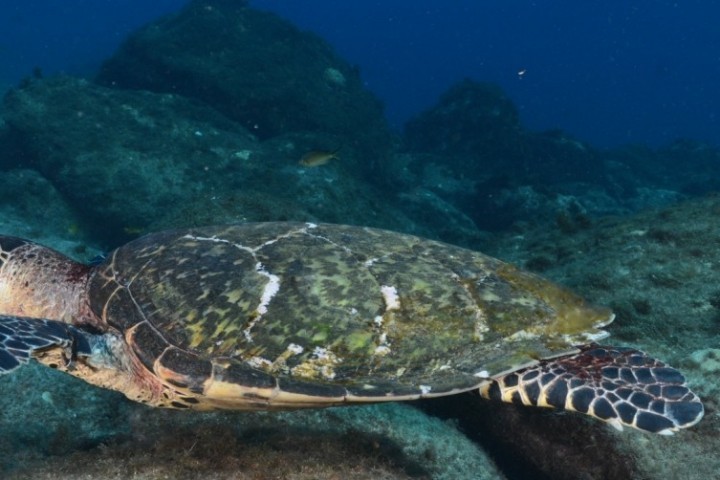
[422,396,645,480]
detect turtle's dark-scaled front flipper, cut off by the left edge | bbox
[0,315,90,375]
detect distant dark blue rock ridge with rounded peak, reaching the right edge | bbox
[396,80,720,230]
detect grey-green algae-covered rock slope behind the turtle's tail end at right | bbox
[486,195,720,479]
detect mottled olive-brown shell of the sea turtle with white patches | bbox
[89,222,612,397]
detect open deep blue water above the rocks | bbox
[0,0,720,146]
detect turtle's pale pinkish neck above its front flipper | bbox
[0,235,90,322]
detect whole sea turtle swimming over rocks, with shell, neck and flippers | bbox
[0,222,703,434]
